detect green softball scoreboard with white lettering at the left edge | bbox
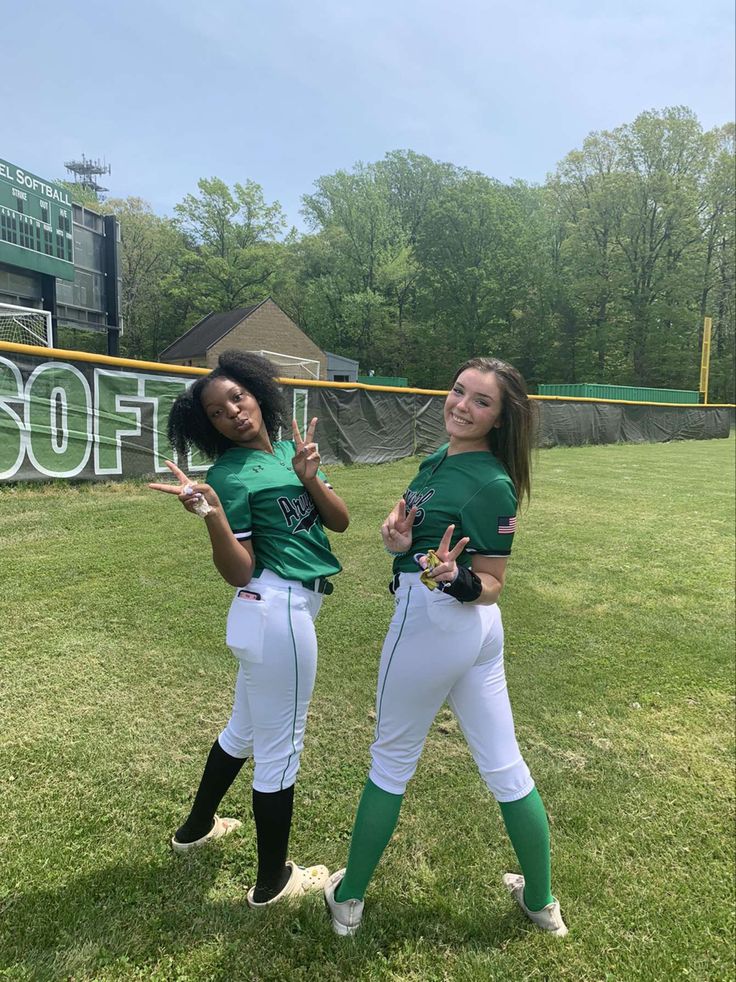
[0,160,74,280]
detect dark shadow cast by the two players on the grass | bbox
[0,849,527,980]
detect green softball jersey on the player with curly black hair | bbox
[207,440,342,582]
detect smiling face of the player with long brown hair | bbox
[444,368,503,453]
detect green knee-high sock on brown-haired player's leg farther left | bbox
[335,779,404,903]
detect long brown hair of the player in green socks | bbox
[452,358,537,504]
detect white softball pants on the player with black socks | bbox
[218,570,322,792]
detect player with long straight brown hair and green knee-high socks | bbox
[324,358,567,936]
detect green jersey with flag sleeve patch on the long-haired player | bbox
[393,444,516,573]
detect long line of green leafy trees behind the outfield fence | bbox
[66,107,736,402]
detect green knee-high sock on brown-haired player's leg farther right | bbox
[499,788,554,910]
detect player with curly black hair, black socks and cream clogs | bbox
[149,351,349,907]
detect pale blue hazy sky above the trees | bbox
[0,0,735,226]
